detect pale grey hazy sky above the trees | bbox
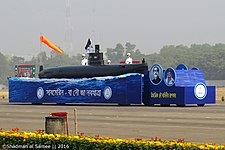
[0,0,225,56]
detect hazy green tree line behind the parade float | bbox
[0,42,225,85]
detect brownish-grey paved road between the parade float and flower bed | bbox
[0,100,225,144]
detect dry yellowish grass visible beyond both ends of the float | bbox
[0,87,225,103]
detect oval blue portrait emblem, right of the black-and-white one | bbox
[163,67,176,86]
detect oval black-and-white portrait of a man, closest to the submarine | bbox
[149,64,163,85]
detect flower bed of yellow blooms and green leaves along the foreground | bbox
[0,128,225,150]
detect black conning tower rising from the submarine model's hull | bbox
[88,44,104,66]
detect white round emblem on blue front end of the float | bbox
[194,83,207,100]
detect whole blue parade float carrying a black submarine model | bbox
[9,39,215,106]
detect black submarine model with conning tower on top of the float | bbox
[39,45,148,79]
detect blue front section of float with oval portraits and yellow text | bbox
[143,64,216,105]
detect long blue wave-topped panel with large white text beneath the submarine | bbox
[9,73,143,104]
